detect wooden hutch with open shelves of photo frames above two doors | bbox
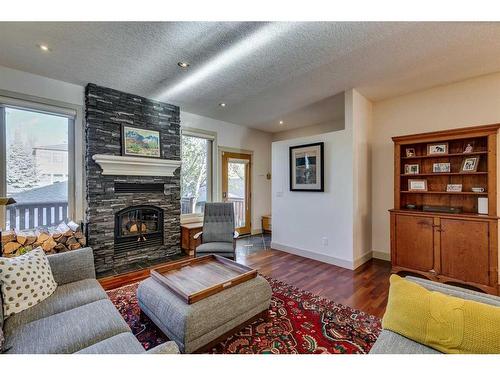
[390,124,500,295]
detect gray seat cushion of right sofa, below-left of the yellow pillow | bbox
[370,329,440,354]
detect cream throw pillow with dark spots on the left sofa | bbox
[0,247,57,318]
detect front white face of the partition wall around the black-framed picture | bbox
[272,130,353,268]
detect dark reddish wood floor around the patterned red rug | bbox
[100,249,391,317]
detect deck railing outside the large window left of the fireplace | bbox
[5,202,68,230]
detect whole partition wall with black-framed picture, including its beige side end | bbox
[272,90,372,269]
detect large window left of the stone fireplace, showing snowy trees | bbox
[0,104,74,231]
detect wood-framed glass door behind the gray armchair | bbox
[222,151,252,235]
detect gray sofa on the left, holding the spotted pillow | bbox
[0,248,179,354]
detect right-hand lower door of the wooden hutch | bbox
[441,219,490,285]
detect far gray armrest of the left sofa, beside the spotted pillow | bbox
[47,247,96,285]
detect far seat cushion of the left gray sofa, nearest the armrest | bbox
[5,279,107,335]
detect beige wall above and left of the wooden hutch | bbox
[371,73,500,258]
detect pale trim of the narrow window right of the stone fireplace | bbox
[180,127,218,224]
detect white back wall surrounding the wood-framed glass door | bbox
[181,111,271,233]
